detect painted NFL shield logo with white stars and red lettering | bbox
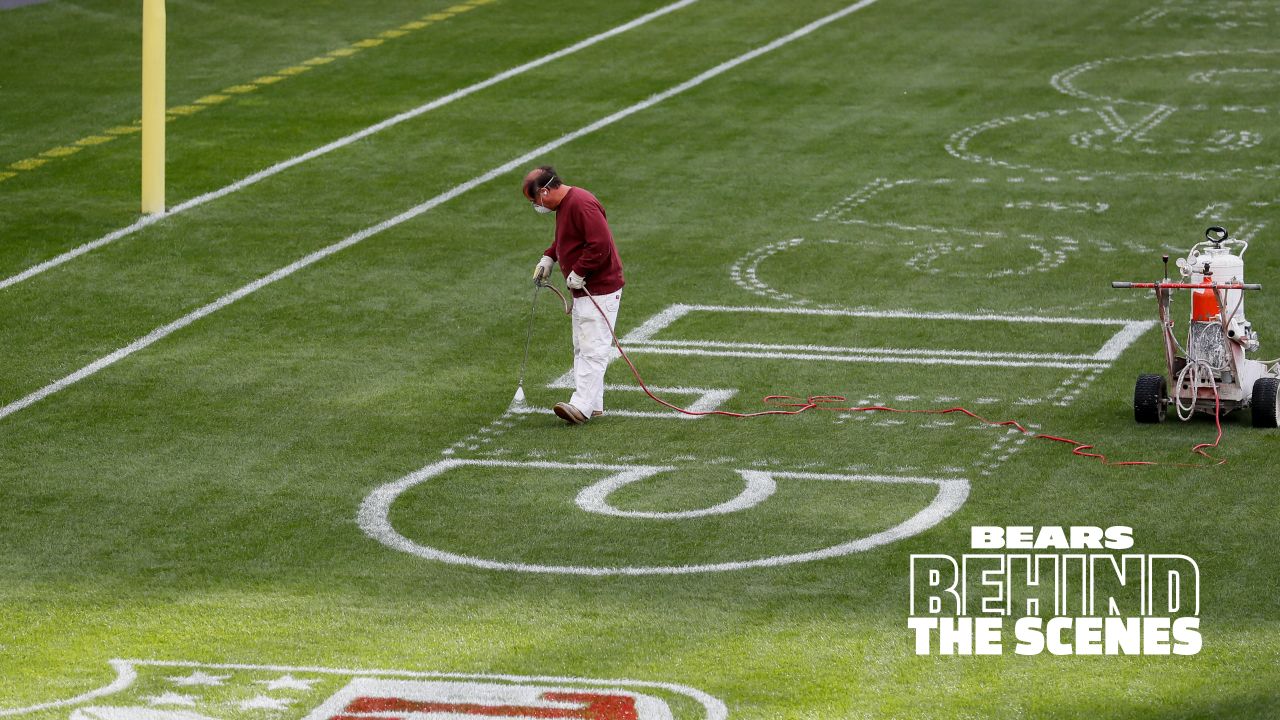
[0,660,728,720]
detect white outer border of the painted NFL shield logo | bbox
[0,660,728,720]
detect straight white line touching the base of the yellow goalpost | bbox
[0,0,698,290]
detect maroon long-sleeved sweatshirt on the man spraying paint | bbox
[543,187,623,297]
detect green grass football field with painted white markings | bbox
[0,0,1280,720]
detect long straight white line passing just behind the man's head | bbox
[0,0,877,419]
